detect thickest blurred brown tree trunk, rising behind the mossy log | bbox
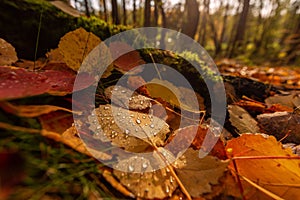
[181,0,200,38]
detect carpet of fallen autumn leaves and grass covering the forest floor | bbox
[0,28,300,199]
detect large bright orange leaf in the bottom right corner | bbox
[226,134,300,199]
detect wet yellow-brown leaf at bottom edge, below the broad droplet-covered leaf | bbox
[113,152,177,199]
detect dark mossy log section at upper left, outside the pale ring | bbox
[0,0,128,60]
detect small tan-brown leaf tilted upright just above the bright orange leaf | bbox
[228,105,260,133]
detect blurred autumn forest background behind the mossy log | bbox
[16,0,300,65]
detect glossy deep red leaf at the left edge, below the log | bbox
[0,66,94,100]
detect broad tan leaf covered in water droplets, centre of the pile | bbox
[89,104,169,152]
